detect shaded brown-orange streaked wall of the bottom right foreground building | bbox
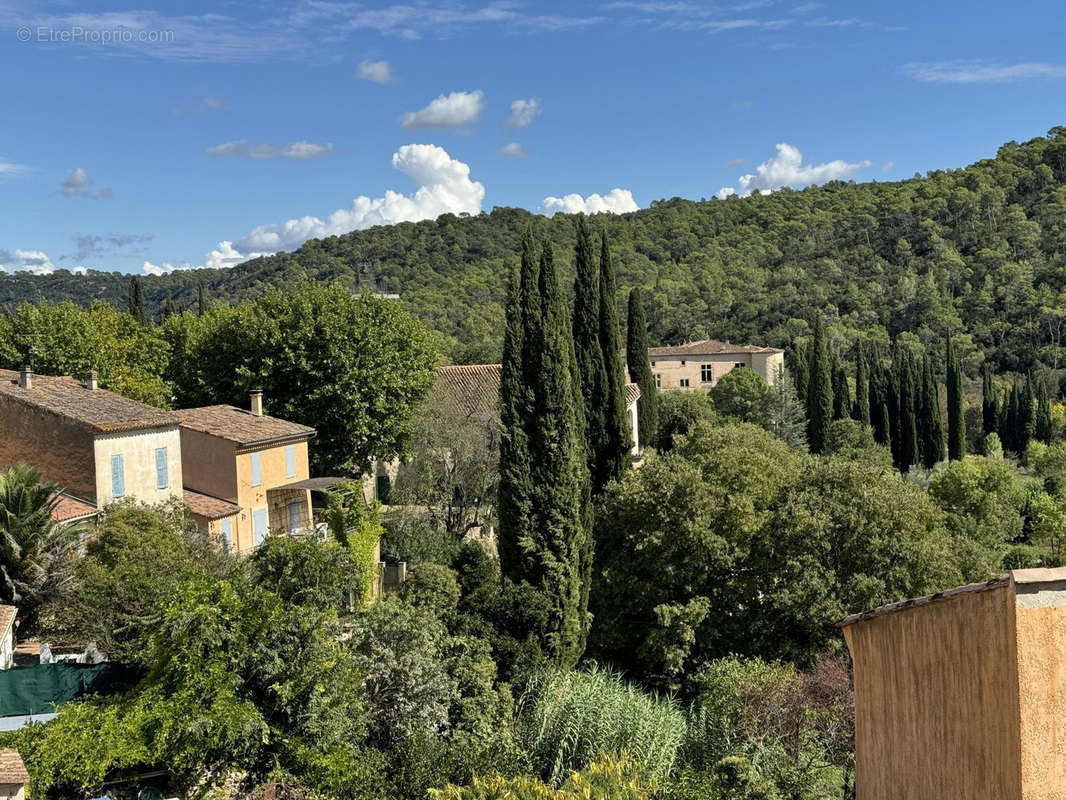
[844,583,1023,800]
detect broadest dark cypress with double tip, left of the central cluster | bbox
[499,233,592,668]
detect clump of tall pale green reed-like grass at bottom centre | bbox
[516,667,685,786]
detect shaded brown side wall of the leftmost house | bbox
[0,396,96,502]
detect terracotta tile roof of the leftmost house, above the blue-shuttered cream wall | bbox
[0,369,178,433]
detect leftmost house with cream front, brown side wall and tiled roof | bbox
[0,367,182,519]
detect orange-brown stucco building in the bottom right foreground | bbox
[841,569,1066,800]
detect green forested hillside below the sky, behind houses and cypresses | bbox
[6,127,1066,377]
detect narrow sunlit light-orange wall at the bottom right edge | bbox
[1015,583,1066,800]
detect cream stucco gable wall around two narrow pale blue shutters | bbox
[94,426,182,506]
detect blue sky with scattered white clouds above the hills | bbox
[0,0,1066,272]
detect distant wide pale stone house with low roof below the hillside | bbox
[648,339,785,391]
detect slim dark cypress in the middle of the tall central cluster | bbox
[574,214,610,494]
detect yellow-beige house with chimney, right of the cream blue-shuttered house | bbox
[176,390,314,553]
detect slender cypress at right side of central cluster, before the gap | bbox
[593,230,632,494]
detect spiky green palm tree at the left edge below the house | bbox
[0,464,81,628]
